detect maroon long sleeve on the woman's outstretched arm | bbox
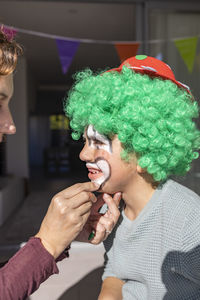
[0,237,59,300]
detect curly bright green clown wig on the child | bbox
[65,66,200,181]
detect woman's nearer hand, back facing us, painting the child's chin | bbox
[36,182,99,258]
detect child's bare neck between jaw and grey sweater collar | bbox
[122,176,157,220]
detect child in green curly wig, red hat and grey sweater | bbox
[66,55,200,300]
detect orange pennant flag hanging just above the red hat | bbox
[115,43,140,62]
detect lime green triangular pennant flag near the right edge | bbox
[175,37,198,73]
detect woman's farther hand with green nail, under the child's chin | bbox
[76,192,121,245]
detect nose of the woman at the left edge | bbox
[0,109,16,134]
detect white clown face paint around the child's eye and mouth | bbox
[86,125,112,185]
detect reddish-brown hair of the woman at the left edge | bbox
[0,27,23,76]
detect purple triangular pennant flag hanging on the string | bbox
[56,39,80,74]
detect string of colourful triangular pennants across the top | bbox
[1,25,200,74]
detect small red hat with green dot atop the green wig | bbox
[107,55,191,94]
